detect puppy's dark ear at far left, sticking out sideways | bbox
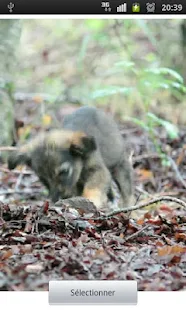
[8,151,31,170]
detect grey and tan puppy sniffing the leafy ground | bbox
[8,107,133,208]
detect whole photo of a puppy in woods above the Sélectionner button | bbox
[0,18,186,291]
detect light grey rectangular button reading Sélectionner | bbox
[49,280,137,305]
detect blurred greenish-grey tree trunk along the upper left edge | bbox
[0,19,21,157]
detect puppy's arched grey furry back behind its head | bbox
[63,107,125,167]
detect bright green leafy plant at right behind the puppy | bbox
[91,61,186,165]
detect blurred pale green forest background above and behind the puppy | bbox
[0,19,186,150]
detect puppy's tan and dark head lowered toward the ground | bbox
[8,130,96,201]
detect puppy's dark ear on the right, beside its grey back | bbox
[70,136,97,157]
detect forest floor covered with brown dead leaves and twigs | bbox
[0,101,186,291]
